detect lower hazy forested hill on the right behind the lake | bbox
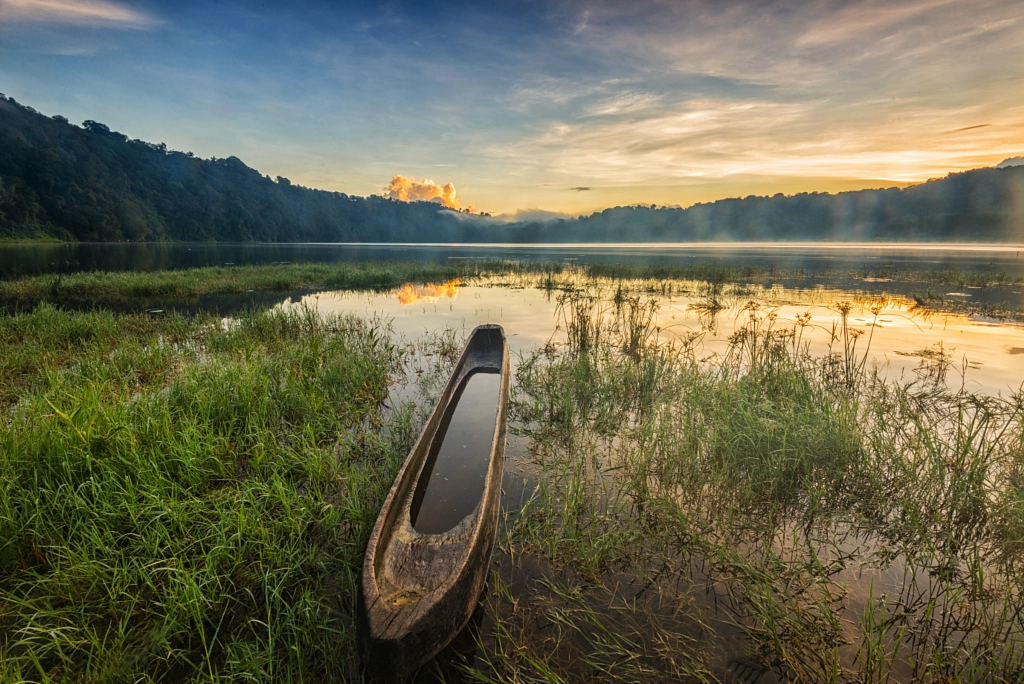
[517,166,1024,243]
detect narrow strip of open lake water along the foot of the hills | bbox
[0,243,1024,277]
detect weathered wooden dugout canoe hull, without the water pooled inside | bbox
[356,326,509,679]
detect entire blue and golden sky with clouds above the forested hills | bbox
[0,0,1024,217]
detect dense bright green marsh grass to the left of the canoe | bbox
[0,306,423,681]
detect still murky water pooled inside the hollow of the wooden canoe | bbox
[411,371,502,535]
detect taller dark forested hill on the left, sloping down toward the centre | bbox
[0,98,468,242]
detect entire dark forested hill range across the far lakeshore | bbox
[0,96,1024,243]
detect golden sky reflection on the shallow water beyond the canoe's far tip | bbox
[288,282,1024,394]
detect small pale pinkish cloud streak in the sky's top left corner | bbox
[0,0,160,29]
